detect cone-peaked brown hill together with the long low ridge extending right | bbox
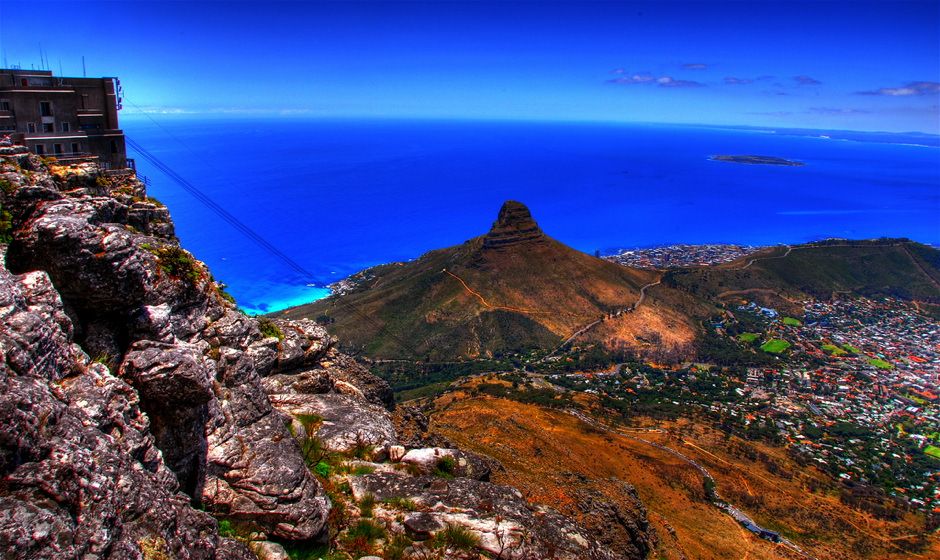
[286,201,940,363]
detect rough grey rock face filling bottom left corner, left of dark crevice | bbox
[0,263,251,560]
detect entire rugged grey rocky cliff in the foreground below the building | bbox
[0,145,652,559]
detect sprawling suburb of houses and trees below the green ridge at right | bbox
[548,298,940,510]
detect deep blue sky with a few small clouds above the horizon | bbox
[0,0,940,134]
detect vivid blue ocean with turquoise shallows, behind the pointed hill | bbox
[122,115,940,313]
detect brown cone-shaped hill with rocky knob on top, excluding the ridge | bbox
[282,201,694,359]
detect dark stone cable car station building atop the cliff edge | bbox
[0,69,133,169]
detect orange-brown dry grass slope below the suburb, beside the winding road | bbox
[432,395,940,560]
